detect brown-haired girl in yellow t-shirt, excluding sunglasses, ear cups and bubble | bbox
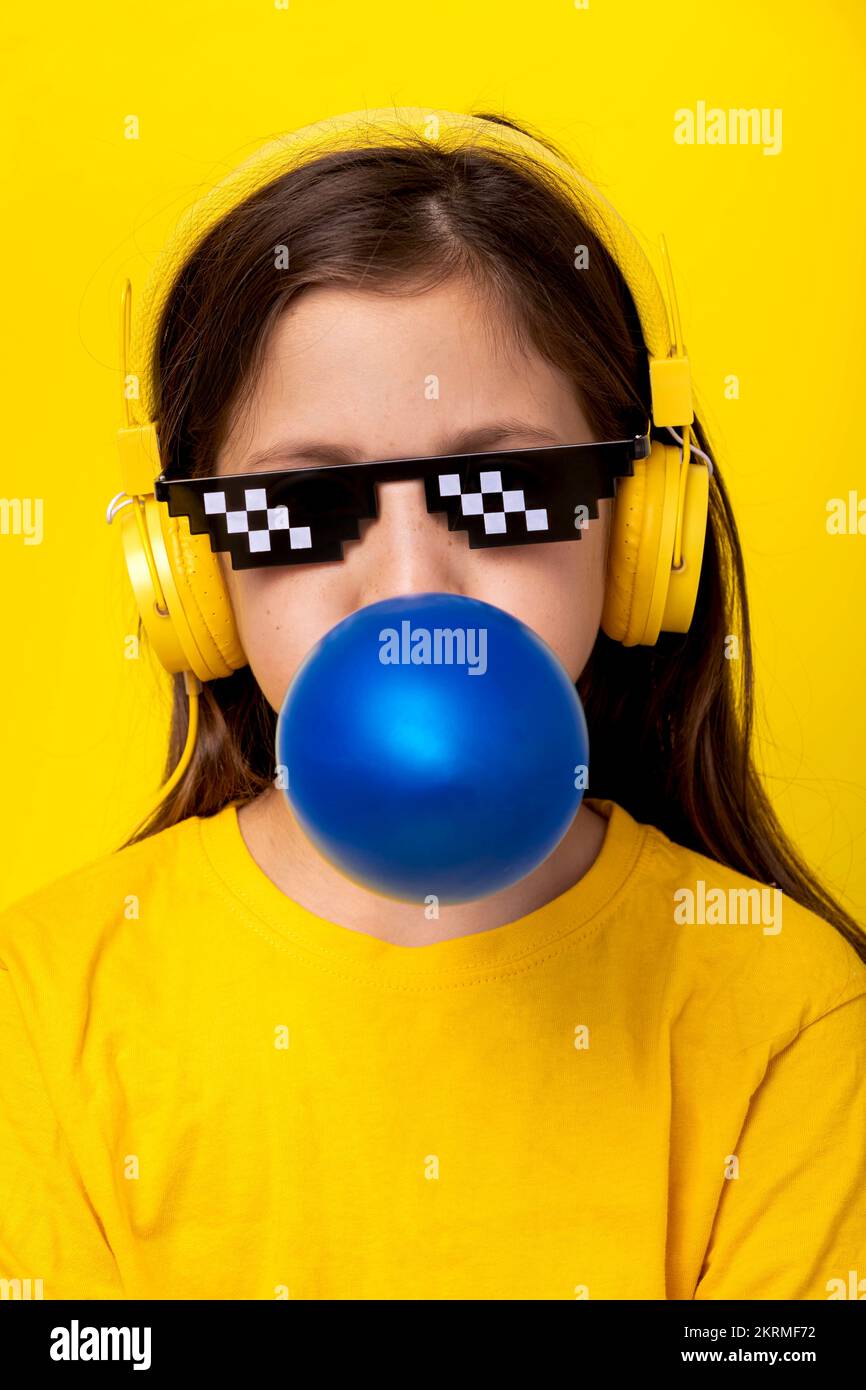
[0,111,866,1300]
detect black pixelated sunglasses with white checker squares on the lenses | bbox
[154,434,651,570]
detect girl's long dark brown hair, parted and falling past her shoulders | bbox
[116,113,866,960]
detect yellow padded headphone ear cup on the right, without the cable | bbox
[602,441,697,646]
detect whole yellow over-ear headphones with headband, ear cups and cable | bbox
[107,107,712,796]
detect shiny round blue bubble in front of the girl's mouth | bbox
[277,594,588,904]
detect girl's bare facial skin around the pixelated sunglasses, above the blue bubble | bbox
[217,272,610,710]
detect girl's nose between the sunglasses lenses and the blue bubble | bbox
[348,478,468,603]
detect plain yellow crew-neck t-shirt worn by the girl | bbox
[0,801,866,1300]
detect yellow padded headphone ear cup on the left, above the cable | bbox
[120,496,247,681]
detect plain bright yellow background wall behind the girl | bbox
[0,0,866,920]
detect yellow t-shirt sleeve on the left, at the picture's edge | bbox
[0,963,124,1300]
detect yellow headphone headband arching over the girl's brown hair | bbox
[124,107,694,427]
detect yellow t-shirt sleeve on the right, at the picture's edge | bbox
[694,994,866,1300]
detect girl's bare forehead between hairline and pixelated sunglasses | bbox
[219,279,582,457]
